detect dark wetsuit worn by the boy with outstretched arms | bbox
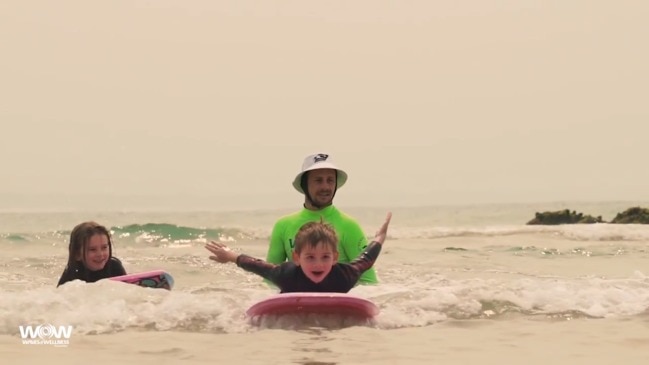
[237,242,381,293]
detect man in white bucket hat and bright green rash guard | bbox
[266,153,378,284]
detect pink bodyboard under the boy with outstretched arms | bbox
[246,293,379,318]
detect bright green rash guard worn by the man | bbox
[266,205,378,284]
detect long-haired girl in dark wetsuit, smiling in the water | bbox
[56,222,126,287]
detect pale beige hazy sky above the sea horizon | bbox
[0,0,649,209]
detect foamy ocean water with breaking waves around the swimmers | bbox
[0,202,649,364]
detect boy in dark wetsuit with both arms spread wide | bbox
[205,213,392,293]
